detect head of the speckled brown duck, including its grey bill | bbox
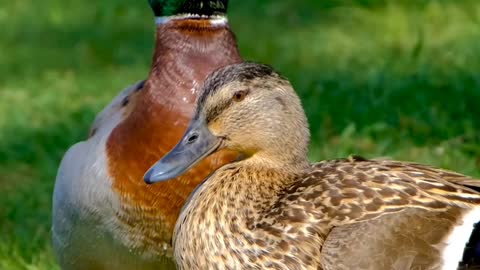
[144,62,310,183]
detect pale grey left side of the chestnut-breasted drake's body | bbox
[52,82,168,270]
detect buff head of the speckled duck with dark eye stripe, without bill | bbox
[196,63,310,166]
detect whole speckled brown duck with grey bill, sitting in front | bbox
[144,62,480,270]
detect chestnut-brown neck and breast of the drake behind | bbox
[107,19,242,245]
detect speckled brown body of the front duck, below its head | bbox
[174,159,480,269]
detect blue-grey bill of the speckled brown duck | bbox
[143,117,221,184]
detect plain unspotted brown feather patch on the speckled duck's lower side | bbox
[321,208,462,270]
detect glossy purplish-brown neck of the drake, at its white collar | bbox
[146,15,242,115]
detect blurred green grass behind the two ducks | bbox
[0,0,480,269]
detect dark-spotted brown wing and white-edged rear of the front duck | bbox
[296,158,480,269]
